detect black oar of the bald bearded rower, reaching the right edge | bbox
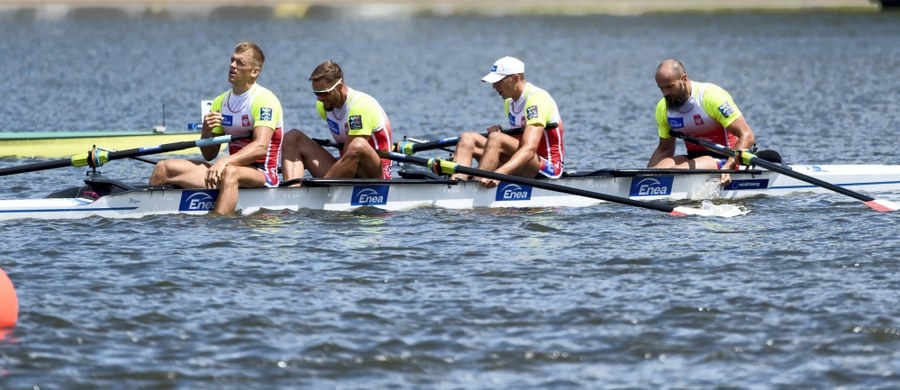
[672,131,900,212]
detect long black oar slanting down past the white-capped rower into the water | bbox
[378,152,713,217]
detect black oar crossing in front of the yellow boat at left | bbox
[0,134,252,176]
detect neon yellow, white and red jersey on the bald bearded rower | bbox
[656,81,741,152]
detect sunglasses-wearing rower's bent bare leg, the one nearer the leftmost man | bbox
[281,129,336,187]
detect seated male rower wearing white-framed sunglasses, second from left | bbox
[281,60,391,186]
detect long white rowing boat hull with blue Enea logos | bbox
[0,165,900,220]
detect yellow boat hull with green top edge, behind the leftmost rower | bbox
[0,132,209,158]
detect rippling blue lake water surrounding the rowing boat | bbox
[0,9,900,389]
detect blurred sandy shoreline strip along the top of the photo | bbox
[0,0,882,20]
